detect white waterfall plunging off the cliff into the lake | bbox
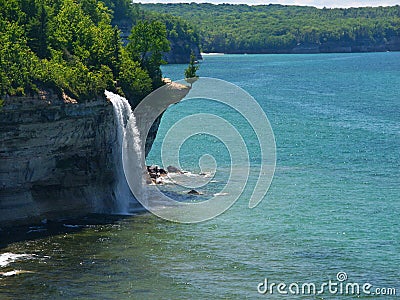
[105,91,143,214]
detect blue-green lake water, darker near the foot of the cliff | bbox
[0,53,400,299]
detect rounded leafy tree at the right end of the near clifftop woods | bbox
[127,20,169,88]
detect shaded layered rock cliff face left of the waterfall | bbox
[0,95,117,225]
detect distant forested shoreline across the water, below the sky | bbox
[141,3,400,53]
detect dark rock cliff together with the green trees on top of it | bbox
[0,0,198,226]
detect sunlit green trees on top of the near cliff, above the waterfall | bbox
[0,0,169,101]
